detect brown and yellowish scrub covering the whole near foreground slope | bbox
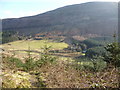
[2,52,118,88]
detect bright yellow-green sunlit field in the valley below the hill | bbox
[2,40,68,51]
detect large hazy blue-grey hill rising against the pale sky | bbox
[2,2,118,35]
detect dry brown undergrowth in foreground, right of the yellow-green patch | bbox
[40,62,118,88]
